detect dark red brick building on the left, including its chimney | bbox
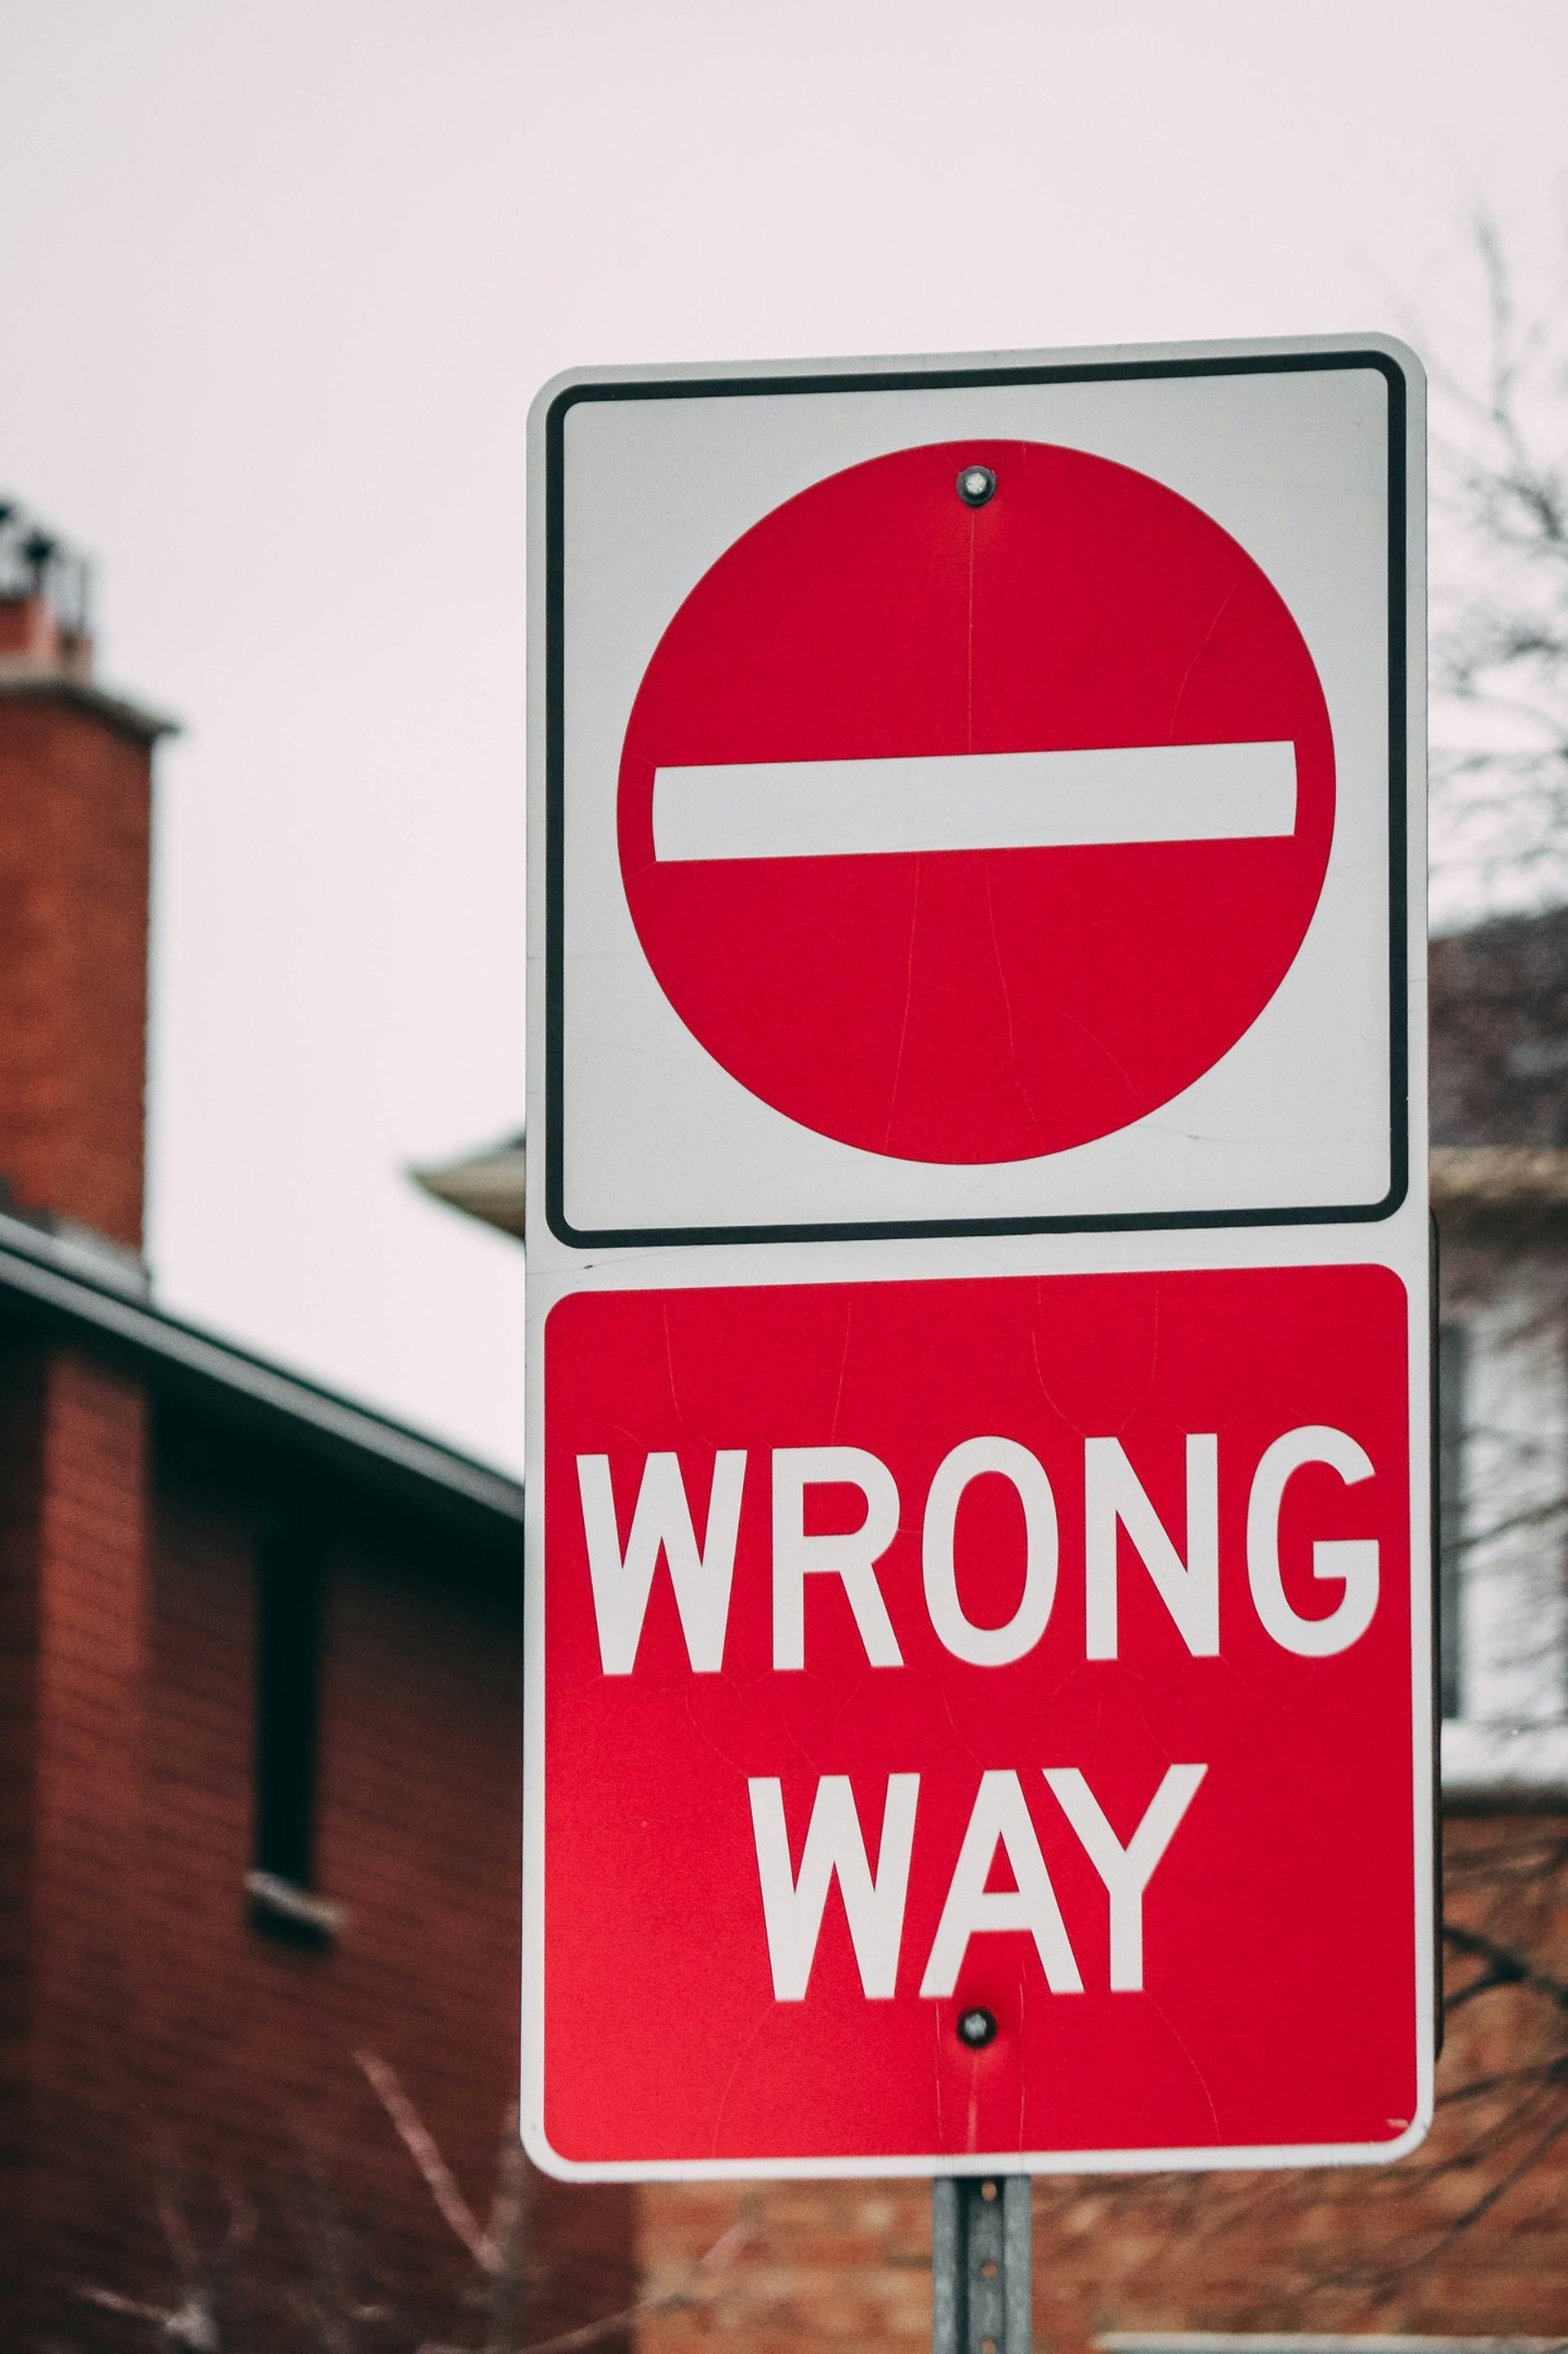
[0,515,631,2354]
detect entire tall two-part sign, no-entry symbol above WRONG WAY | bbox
[523,341,1432,2180]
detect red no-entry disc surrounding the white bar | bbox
[619,440,1335,1163]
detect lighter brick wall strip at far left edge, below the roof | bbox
[5,1347,146,2319]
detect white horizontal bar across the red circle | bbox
[654,744,1295,859]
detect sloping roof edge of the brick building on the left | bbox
[0,1212,523,1535]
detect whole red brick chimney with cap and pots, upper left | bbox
[0,504,170,1252]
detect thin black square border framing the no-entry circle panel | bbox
[544,350,1410,1250]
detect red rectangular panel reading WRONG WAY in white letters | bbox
[534,1267,1419,2173]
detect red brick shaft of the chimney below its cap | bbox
[0,694,151,1247]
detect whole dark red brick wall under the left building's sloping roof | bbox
[0,1335,635,2354]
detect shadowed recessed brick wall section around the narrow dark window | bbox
[118,1412,631,2354]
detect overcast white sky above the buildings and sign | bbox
[0,0,1568,1465]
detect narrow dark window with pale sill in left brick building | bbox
[245,1514,339,1945]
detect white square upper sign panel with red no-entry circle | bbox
[537,349,1413,1250]
